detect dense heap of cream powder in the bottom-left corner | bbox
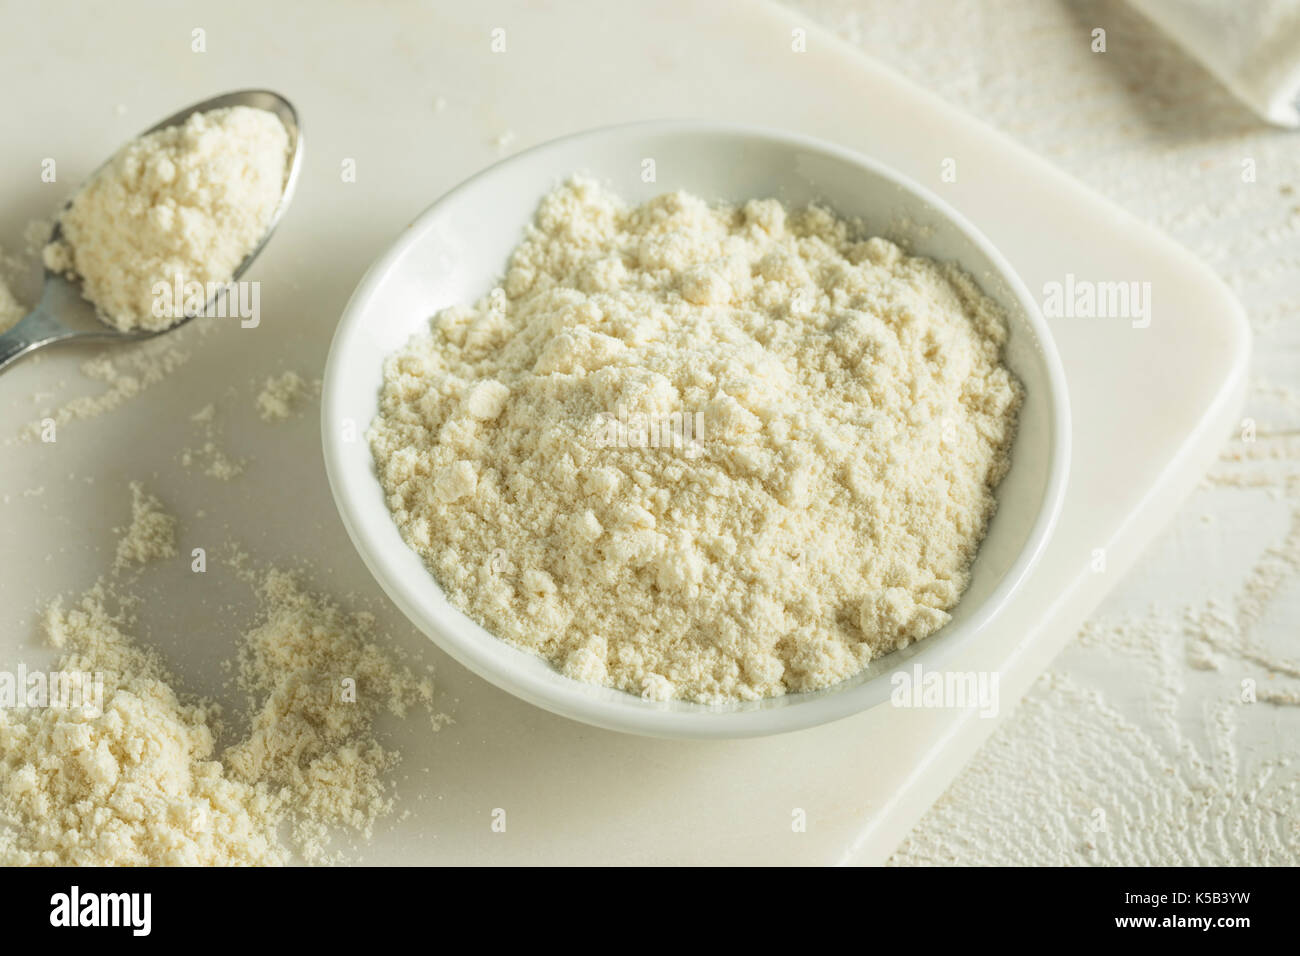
[0,587,287,866]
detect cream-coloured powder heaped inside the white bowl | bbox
[368,179,1022,702]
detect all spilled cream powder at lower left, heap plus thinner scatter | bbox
[0,486,438,865]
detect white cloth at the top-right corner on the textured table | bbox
[1130,0,1300,127]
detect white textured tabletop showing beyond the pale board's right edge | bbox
[793,0,1300,864]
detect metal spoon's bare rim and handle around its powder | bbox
[0,90,303,372]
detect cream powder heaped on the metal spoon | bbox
[43,107,290,332]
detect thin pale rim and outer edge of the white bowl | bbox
[321,120,1071,739]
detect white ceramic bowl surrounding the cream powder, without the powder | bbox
[321,121,1070,737]
